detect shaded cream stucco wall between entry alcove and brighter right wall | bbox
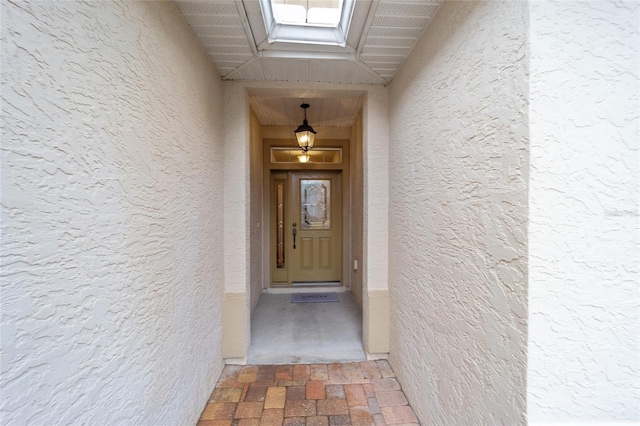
[389,1,528,425]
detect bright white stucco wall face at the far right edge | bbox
[527,1,640,424]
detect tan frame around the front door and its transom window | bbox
[262,138,352,292]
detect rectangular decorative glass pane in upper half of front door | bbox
[300,179,331,229]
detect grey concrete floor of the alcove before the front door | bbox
[248,293,365,364]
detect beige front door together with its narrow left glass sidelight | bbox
[271,172,342,285]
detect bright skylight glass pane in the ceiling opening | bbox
[270,0,343,27]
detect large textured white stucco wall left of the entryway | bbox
[0,1,223,425]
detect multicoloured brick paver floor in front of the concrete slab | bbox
[198,360,418,426]
